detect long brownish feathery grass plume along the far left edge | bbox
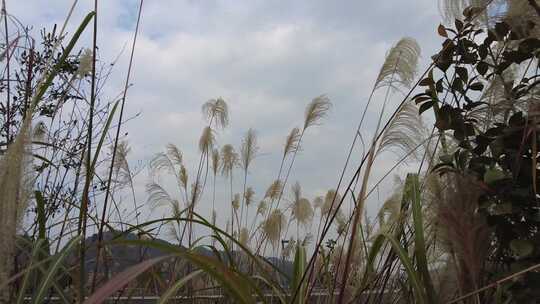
[0,116,33,300]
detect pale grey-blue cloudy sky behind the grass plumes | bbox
[10,0,448,242]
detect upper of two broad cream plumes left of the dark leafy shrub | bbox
[375,37,420,88]
